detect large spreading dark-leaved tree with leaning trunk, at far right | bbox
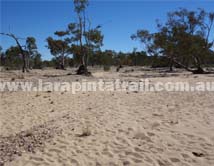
[131,9,214,73]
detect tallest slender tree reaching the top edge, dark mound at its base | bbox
[60,0,103,74]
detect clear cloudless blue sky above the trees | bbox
[0,0,214,59]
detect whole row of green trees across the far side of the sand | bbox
[0,0,214,75]
